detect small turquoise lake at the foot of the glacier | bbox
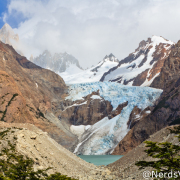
[78,155,122,166]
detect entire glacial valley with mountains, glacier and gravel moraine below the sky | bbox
[0,21,180,180]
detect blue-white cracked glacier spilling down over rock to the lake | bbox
[66,81,162,155]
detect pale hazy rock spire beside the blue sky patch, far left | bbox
[0,23,23,55]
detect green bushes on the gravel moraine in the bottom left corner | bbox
[0,141,75,180]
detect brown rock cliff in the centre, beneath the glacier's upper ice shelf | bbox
[60,92,113,125]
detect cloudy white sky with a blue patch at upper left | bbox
[0,0,180,68]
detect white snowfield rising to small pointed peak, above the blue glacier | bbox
[60,54,119,84]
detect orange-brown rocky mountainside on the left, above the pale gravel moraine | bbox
[0,42,76,148]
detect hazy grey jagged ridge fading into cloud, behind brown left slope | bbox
[30,50,82,74]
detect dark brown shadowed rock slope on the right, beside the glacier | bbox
[113,41,180,154]
